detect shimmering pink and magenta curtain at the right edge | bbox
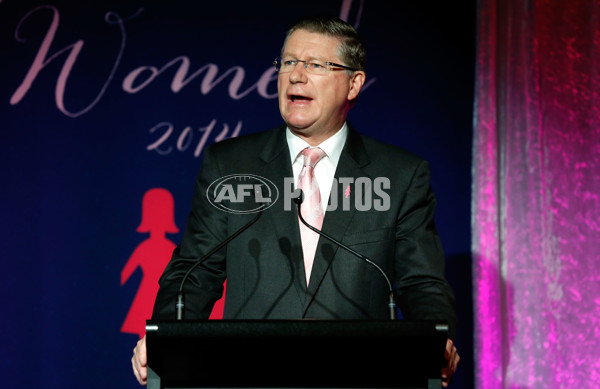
[472,0,600,389]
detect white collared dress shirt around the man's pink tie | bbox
[286,123,348,213]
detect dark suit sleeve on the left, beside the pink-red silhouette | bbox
[152,147,228,320]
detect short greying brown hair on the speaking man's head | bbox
[281,16,367,70]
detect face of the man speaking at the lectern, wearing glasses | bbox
[277,30,365,145]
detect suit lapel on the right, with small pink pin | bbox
[303,126,369,317]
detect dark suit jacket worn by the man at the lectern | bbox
[153,123,455,335]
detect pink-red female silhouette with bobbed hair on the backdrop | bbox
[121,188,179,338]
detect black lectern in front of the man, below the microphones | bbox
[146,320,448,389]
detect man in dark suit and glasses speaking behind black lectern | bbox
[132,17,459,386]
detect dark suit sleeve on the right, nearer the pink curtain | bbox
[395,161,456,338]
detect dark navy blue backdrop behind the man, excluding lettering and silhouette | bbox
[0,0,476,388]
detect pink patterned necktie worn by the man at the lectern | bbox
[298,147,325,285]
